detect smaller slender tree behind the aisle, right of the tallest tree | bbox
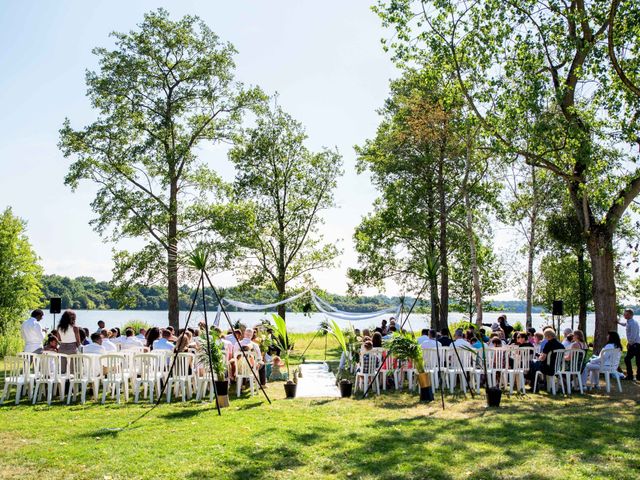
[229,106,342,318]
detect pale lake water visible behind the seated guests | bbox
[42,310,625,337]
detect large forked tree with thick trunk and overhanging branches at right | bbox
[378,0,640,349]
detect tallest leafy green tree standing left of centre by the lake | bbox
[60,9,261,327]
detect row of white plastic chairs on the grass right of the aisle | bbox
[356,347,622,395]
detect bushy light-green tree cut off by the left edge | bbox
[0,208,42,356]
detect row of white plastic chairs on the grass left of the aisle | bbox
[0,351,228,405]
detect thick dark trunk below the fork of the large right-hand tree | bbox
[587,227,618,353]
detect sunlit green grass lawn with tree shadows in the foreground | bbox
[0,337,640,480]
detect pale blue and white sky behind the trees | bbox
[0,0,516,294]
